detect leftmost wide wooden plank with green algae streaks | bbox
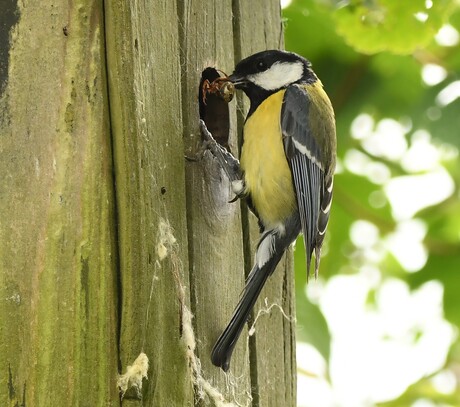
[0,0,119,406]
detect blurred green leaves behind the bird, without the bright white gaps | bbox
[283,0,460,406]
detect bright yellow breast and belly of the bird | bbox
[241,91,297,228]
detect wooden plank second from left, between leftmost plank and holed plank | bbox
[106,0,193,406]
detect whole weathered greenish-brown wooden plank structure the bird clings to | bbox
[0,0,296,406]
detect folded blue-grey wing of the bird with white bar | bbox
[281,85,332,276]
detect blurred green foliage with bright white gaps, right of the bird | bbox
[282,0,460,407]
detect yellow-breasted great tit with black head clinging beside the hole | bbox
[202,50,336,371]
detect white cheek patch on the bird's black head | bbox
[248,61,303,90]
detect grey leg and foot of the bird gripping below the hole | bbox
[200,120,245,202]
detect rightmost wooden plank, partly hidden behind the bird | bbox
[234,0,297,406]
